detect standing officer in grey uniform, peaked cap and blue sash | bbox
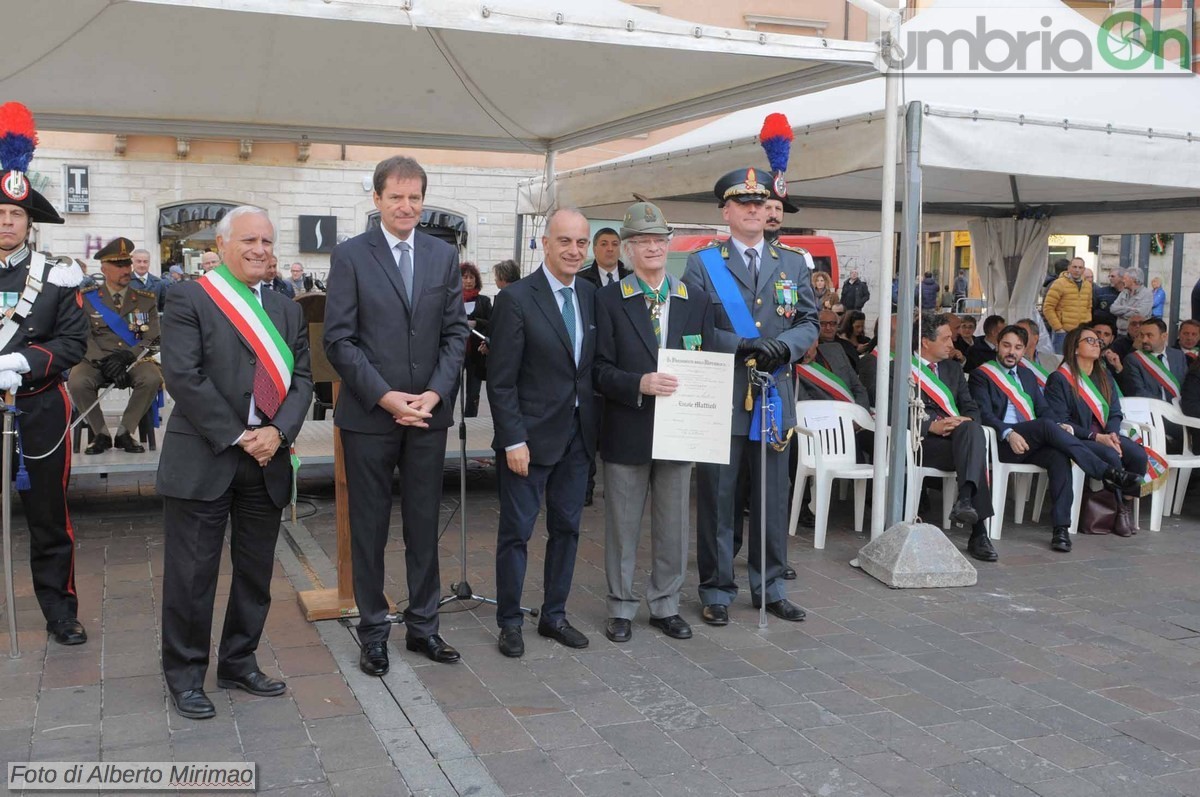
[683,169,818,625]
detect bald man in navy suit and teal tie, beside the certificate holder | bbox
[487,210,596,658]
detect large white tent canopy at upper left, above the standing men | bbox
[0,0,880,152]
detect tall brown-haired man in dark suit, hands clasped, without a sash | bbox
[325,156,468,676]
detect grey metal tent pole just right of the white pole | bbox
[887,102,922,527]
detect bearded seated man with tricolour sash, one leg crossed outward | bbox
[970,324,1141,553]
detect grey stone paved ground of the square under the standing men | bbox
[0,467,1200,797]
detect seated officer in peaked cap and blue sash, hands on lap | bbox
[67,238,162,454]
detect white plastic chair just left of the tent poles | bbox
[787,401,875,549]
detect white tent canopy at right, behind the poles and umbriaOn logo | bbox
[540,0,1200,233]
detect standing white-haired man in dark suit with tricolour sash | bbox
[156,206,312,719]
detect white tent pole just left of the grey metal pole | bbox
[871,24,901,539]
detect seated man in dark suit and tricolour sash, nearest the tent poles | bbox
[912,313,1000,562]
